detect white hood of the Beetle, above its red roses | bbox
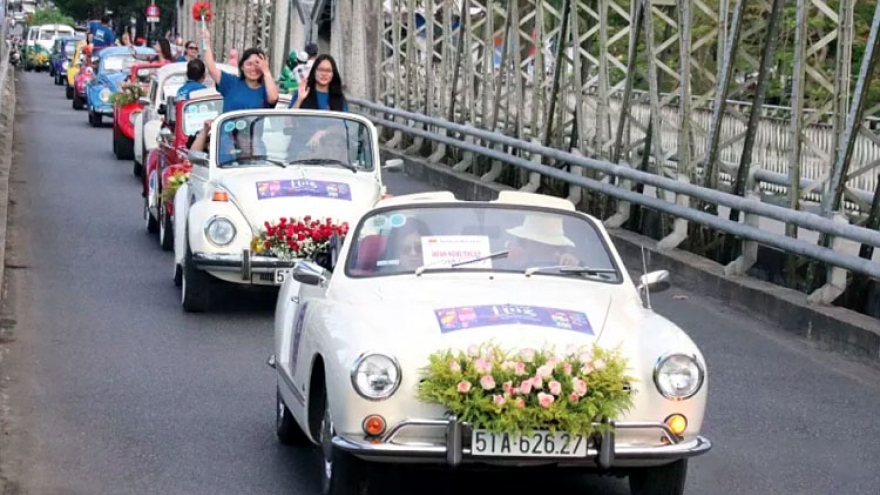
[216,167,381,230]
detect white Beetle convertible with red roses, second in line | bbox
[173,109,401,311]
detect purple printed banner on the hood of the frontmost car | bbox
[434,304,594,335]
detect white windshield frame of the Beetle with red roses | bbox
[209,108,382,176]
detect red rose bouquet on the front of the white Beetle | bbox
[251,216,348,260]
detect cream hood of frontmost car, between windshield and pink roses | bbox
[338,274,641,359]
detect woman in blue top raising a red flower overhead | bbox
[202,29,278,113]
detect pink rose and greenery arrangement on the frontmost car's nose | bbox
[418,343,635,435]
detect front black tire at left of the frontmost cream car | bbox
[320,385,369,495]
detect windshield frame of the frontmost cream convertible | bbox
[334,201,628,285]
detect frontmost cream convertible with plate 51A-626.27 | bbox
[268,192,711,495]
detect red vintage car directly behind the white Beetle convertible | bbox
[143,89,223,250]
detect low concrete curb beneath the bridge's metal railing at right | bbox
[382,147,880,365]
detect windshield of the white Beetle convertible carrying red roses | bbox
[217,113,374,173]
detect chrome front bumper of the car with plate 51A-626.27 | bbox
[333,420,712,469]
